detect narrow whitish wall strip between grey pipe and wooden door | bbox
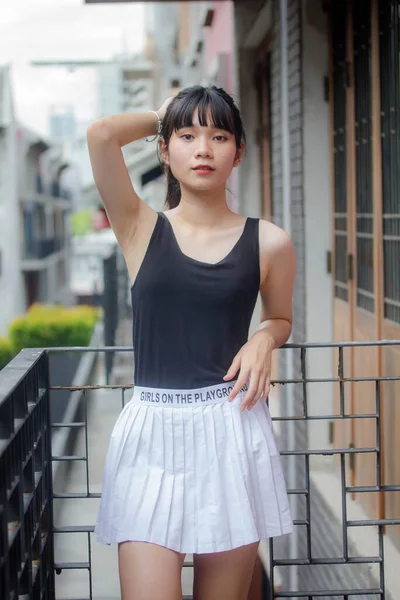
[303,0,333,448]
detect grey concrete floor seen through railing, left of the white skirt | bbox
[54,360,193,600]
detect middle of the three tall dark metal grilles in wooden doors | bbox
[353,0,374,312]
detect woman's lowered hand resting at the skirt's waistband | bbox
[223,330,275,410]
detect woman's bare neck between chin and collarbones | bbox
[173,184,232,226]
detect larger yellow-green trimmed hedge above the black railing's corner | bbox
[9,304,99,353]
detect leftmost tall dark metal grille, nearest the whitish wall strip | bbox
[331,2,348,301]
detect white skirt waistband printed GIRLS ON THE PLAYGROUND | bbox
[131,381,248,408]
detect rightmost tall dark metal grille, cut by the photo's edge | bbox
[379,0,400,323]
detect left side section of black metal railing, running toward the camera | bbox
[0,350,54,600]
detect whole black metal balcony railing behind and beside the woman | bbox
[0,341,400,600]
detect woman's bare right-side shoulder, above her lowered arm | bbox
[259,219,296,278]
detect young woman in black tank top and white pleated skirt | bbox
[87,86,295,600]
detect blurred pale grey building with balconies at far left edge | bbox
[0,67,71,335]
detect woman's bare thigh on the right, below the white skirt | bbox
[193,542,258,600]
